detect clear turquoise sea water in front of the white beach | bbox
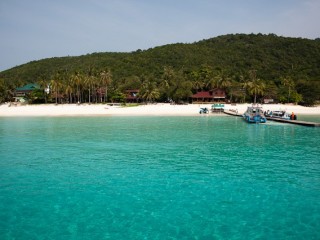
[0,115,320,240]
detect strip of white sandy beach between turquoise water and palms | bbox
[0,103,320,117]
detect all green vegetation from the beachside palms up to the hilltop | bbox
[0,34,320,105]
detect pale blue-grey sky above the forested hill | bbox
[0,0,320,71]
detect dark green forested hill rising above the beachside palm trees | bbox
[0,34,320,82]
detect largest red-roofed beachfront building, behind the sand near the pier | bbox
[192,88,226,103]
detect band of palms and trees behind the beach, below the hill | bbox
[0,66,320,105]
